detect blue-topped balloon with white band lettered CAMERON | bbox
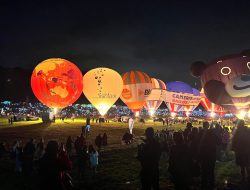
[165,81,193,115]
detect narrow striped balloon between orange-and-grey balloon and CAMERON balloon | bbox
[144,78,166,116]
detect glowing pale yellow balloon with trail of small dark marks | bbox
[83,68,123,116]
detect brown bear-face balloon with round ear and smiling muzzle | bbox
[191,51,250,109]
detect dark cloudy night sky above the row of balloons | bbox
[0,0,250,86]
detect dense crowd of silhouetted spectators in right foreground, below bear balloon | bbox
[138,120,250,190]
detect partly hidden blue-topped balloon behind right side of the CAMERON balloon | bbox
[183,88,201,116]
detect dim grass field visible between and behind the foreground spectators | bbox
[0,119,244,190]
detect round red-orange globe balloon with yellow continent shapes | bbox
[31,58,83,108]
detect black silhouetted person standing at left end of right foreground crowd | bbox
[137,127,161,190]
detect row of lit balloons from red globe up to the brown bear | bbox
[31,55,248,116]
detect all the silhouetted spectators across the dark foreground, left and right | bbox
[0,120,250,190]
